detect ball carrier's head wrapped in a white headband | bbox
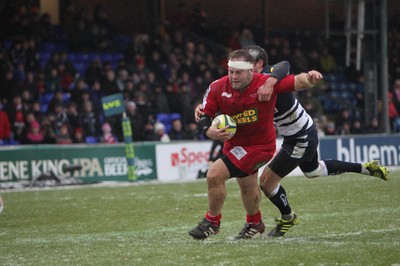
[228,50,254,90]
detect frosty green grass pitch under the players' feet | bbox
[0,172,400,265]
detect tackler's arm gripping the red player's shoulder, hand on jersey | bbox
[257,61,290,102]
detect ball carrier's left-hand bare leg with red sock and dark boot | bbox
[189,159,230,239]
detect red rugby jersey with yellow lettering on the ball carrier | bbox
[203,73,294,147]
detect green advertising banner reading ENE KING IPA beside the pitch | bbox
[0,143,157,183]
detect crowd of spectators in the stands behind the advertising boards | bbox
[0,1,400,144]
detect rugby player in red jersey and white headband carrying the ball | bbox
[189,50,322,239]
